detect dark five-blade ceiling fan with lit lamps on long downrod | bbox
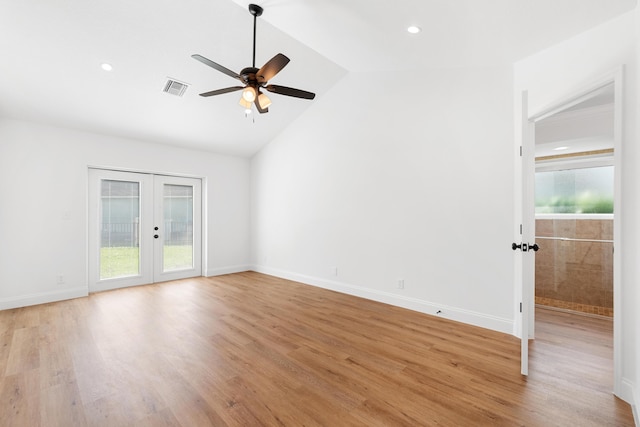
[191,4,316,114]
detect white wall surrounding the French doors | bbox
[0,119,250,309]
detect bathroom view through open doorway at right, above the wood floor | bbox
[535,83,615,318]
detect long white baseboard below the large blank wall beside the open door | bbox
[251,265,513,335]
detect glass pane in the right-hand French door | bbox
[162,184,193,271]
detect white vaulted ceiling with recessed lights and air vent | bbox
[0,0,636,156]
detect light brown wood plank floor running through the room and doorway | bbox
[0,273,633,427]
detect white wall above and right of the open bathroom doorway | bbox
[514,10,640,412]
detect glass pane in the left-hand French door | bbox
[100,179,140,280]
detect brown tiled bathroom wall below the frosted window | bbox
[536,219,613,316]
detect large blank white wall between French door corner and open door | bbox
[252,67,514,333]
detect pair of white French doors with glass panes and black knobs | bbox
[89,169,202,292]
